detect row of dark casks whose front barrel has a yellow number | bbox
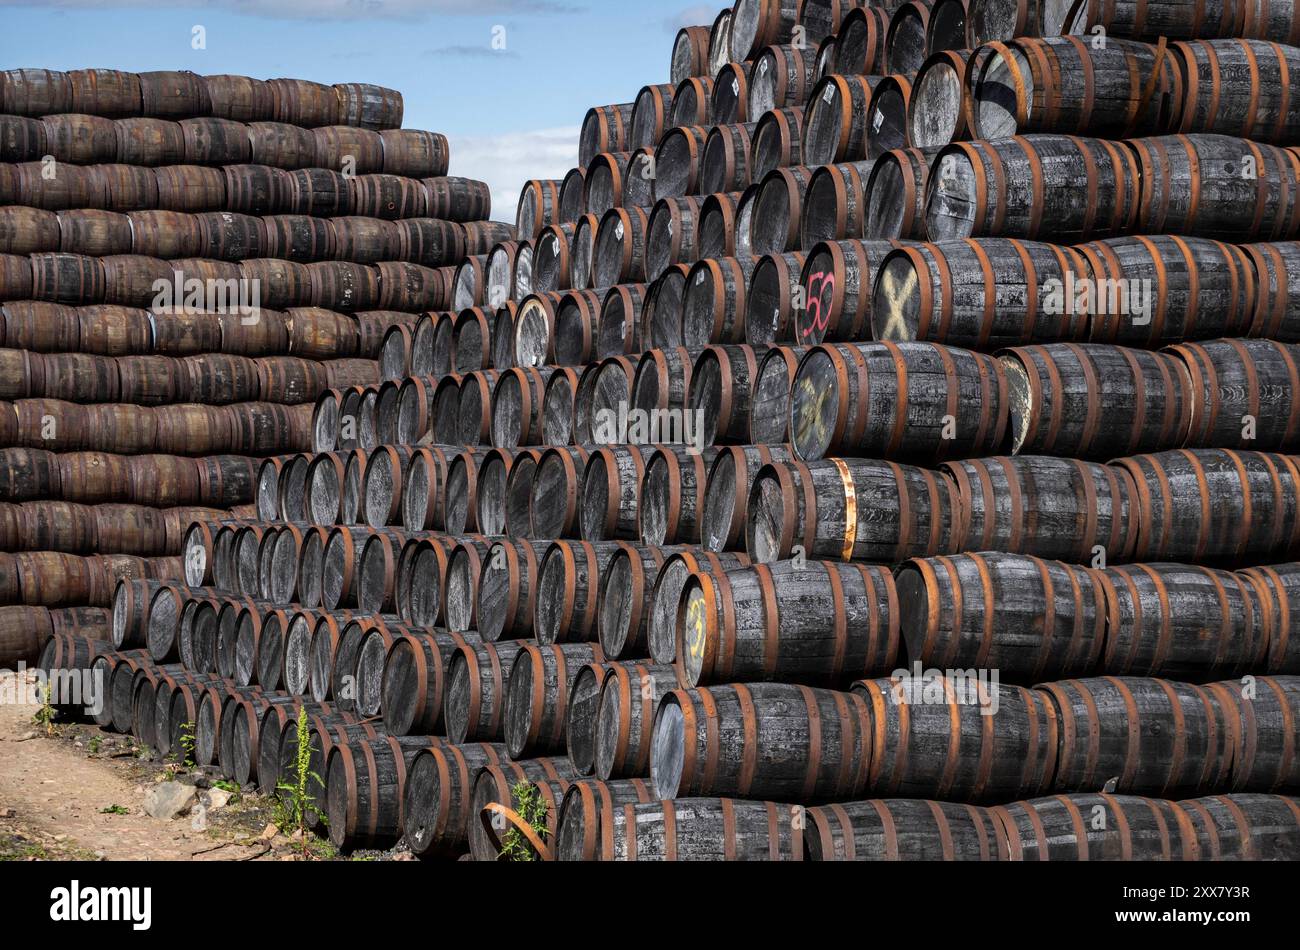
[178,512,1300,686]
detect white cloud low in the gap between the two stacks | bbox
[447,126,580,224]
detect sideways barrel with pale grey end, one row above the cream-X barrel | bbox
[926,134,1138,243]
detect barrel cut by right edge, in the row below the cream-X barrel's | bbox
[1171,339,1300,450]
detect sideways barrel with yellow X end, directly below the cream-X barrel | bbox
[790,343,1010,461]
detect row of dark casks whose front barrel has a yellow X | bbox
[361,335,1300,461]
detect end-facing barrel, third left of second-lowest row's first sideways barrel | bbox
[504,643,605,764]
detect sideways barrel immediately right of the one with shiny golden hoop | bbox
[944,456,1139,567]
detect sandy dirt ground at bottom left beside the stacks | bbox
[0,672,361,860]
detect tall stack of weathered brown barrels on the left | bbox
[0,69,496,668]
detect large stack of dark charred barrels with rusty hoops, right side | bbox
[27,0,1300,860]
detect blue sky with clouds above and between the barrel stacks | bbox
[0,0,723,220]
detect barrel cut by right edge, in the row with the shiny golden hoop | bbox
[1115,448,1300,564]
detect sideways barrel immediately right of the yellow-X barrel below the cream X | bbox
[1001,343,1196,459]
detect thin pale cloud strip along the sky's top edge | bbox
[0,0,586,19]
